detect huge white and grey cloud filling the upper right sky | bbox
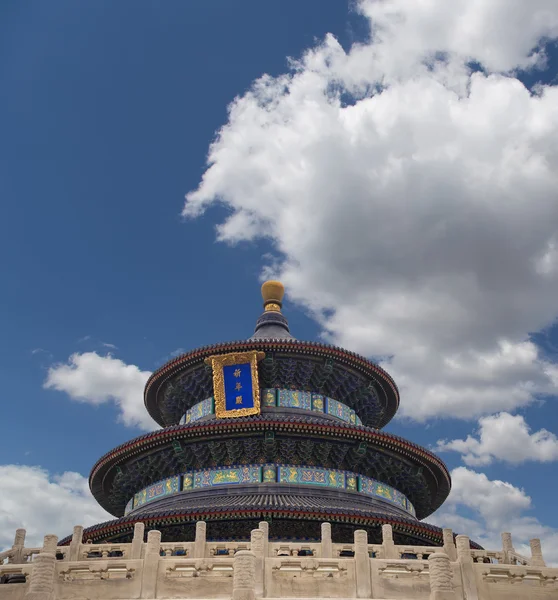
[184,0,558,420]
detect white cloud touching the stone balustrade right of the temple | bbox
[434,467,558,564]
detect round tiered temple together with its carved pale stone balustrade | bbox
[0,281,558,600]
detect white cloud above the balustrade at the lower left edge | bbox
[0,465,114,550]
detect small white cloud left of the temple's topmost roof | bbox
[44,352,158,431]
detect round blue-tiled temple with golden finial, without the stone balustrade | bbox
[60,281,466,547]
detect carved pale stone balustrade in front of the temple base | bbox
[0,521,558,600]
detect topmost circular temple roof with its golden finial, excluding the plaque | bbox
[144,281,399,429]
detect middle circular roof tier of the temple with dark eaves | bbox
[89,413,451,519]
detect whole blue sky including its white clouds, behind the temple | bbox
[0,0,558,560]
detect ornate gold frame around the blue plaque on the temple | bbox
[205,350,265,419]
